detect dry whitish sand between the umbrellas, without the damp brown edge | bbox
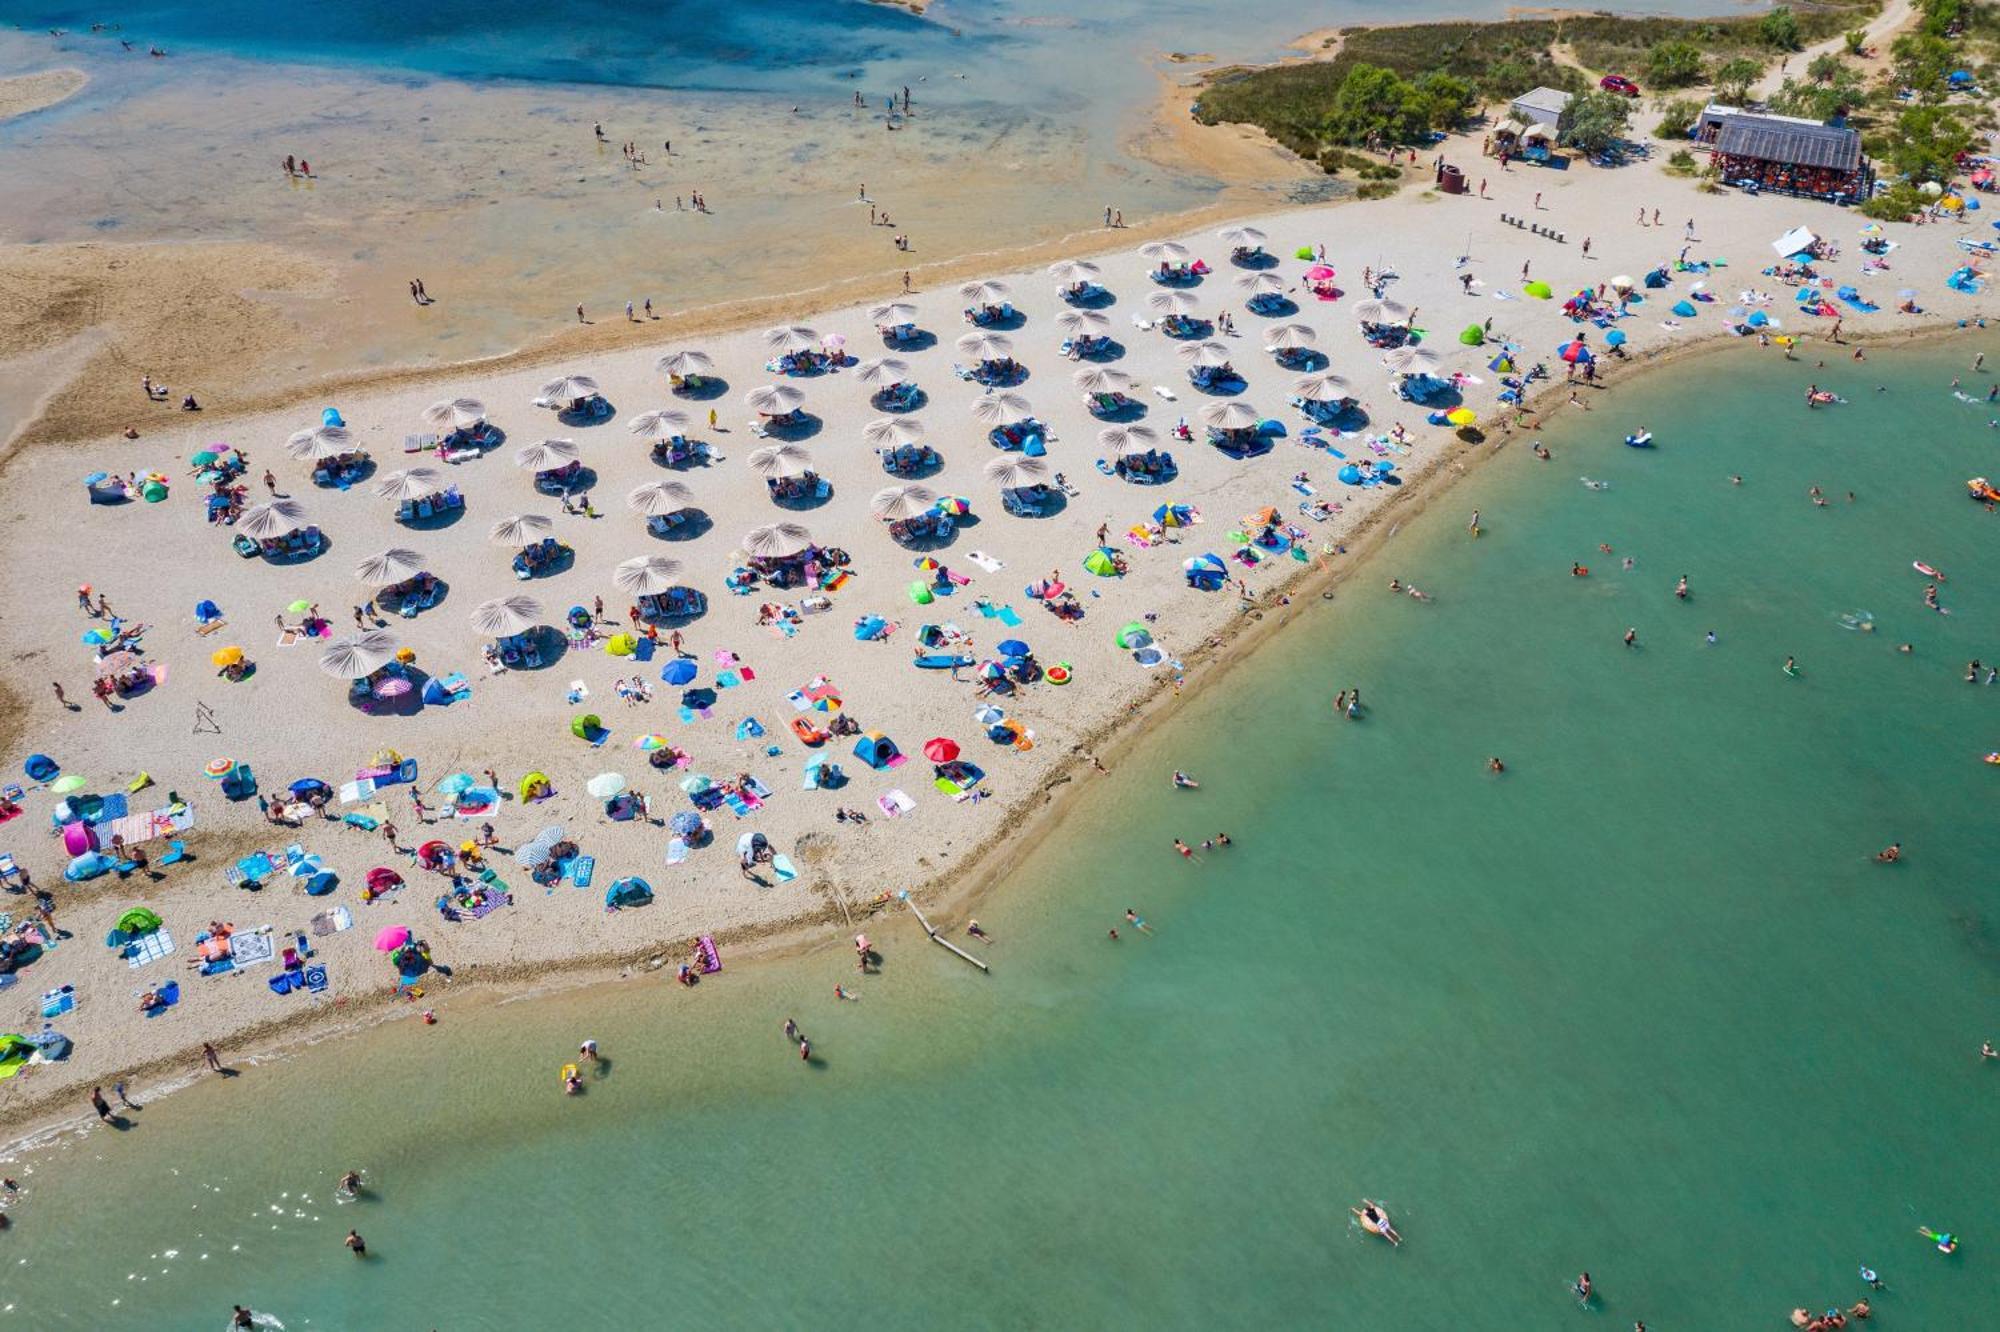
[0,140,1990,1110]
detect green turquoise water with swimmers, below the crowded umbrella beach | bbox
[0,342,2000,1332]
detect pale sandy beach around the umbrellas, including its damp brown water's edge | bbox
[0,80,1984,1124]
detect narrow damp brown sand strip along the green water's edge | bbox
[0,296,1976,1158]
